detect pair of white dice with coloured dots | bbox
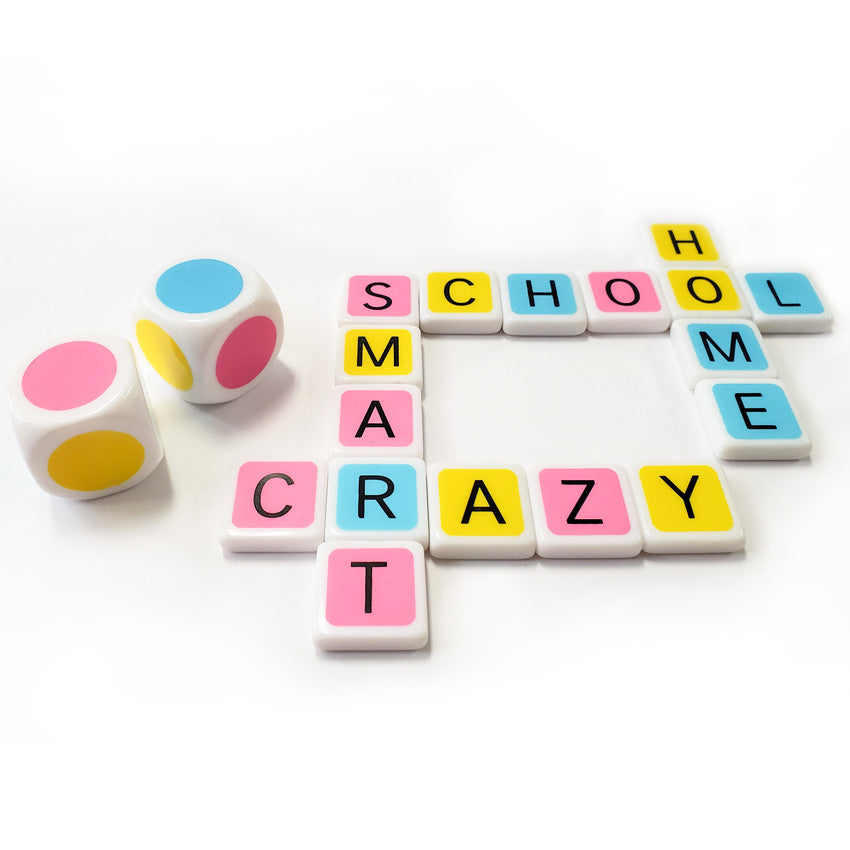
[10,259,283,499]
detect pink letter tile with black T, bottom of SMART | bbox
[313,541,428,650]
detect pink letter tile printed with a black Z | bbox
[529,466,643,558]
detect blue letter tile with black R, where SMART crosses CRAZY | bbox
[325,457,428,548]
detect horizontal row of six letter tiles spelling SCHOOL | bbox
[339,274,832,336]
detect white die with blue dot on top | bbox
[133,259,283,404]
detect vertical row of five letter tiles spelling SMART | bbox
[313,275,428,650]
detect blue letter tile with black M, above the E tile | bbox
[670,319,776,389]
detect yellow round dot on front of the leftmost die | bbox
[47,431,145,493]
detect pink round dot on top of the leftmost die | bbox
[21,340,118,410]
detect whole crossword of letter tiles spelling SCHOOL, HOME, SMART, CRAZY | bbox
[215,224,831,650]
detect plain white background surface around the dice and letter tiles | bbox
[0,0,850,850]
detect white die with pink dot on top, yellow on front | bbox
[9,334,162,499]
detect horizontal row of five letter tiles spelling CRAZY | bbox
[221,457,744,559]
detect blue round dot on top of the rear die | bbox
[156,260,242,313]
